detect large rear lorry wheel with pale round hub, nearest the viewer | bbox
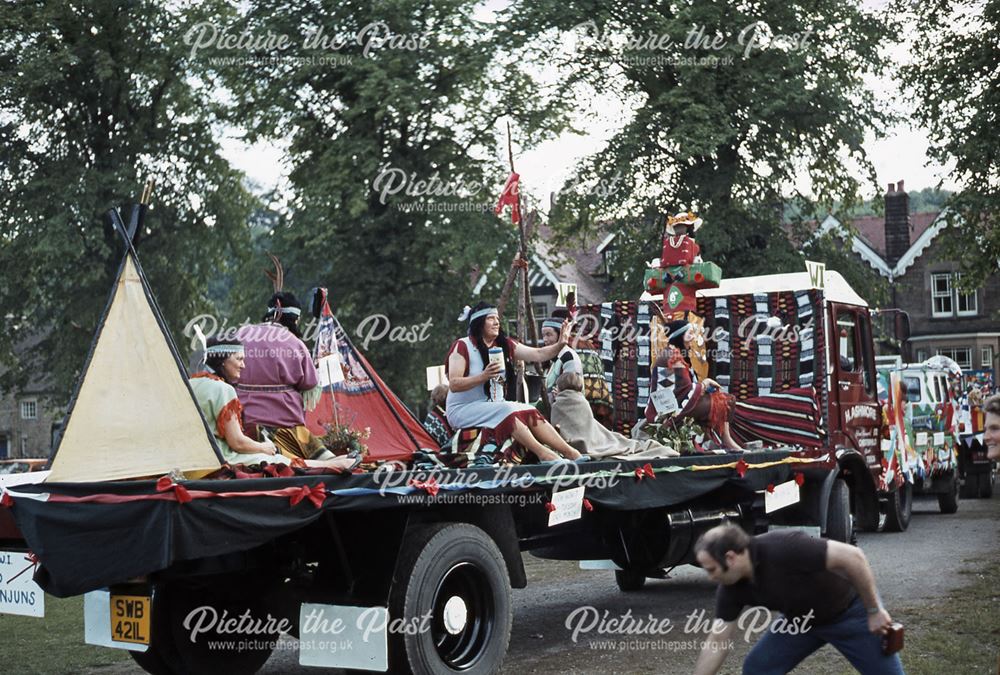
[389,523,514,675]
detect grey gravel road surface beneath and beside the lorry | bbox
[93,498,1000,675]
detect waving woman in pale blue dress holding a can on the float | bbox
[445,303,581,461]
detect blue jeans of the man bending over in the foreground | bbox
[743,598,904,675]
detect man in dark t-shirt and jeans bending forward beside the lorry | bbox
[695,523,903,675]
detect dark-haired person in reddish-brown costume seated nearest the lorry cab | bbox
[646,321,742,451]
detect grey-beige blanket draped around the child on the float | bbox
[552,389,678,460]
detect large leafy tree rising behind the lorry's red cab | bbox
[507,0,894,294]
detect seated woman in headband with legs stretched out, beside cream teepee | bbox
[191,338,358,470]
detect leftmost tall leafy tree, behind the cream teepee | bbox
[0,0,253,402]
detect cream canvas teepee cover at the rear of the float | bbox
[48,251,221,482]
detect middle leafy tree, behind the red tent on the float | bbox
[208,0,562,402]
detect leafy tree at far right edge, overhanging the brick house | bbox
[898,0,1000,290]
